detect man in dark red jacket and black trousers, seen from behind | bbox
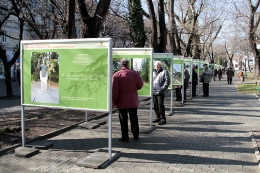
[112,59,143,142]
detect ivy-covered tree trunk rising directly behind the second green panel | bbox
[128,0,146,47]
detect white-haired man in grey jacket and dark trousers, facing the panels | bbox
[153,61,171,125]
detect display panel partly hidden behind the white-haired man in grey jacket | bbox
[153,53,173,89]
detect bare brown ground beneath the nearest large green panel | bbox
[0,108,104,150]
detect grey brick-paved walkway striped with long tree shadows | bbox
[0,77,260,173]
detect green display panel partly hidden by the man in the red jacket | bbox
[112,48,153,97]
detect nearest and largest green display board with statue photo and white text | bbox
[21,38,111,111]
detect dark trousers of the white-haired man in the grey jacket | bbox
[153,95,166,121]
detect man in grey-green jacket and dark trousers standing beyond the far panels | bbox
[201,64,212,97]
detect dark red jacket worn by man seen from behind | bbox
[112,67,143,109]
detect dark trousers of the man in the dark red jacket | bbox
[118,108,139,139]
